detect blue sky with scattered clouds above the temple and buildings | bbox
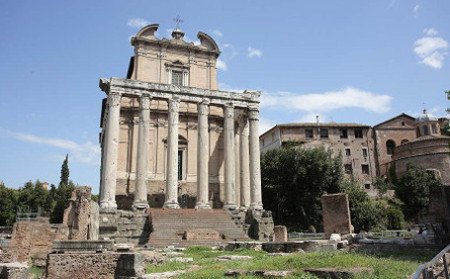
[0,0,450,191]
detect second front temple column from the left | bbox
[133,94,150,209]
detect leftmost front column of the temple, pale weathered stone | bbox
[100,92,121,210]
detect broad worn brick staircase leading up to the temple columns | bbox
[148,208,250,248]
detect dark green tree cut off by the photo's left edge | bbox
[0,182,17,226]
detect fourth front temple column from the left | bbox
[195,99,211,208]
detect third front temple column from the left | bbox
[164,96,180,208]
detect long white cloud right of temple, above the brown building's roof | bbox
[261,87,392,113]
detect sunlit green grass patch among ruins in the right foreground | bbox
[147,247,438,279]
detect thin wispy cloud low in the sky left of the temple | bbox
[9,132,101,166]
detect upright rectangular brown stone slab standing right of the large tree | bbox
[321,193,352,237]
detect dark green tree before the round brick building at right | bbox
[395,165,441,222]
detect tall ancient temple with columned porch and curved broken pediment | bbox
[96,24,273,245]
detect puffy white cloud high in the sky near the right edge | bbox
[414,28,448,69]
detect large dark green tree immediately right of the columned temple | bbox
[261,146,342,230]
